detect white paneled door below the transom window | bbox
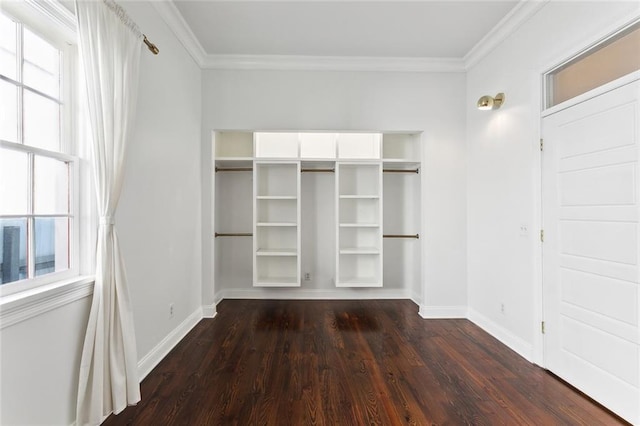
[542,81,640,424]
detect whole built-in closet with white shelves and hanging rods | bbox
[212,131,424,298]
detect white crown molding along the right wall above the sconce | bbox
[463,0,550,70]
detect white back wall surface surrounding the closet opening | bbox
[202,70,467,316]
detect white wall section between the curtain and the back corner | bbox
[116,2,202,366]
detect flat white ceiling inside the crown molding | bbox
[173,0,518,58]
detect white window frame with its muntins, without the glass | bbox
[0,7,82,298]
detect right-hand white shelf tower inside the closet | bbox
[336,162,382,287]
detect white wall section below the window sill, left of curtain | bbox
[0,297,91,425]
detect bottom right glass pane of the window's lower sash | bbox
[35,217,69,277]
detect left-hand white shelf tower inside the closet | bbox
[253,160,300,287]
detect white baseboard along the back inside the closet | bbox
[219,287,410,300]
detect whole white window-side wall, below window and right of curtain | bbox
[0,2,201,425]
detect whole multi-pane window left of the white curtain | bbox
[0,14,77,294]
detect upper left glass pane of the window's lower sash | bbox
[0,149,29,214]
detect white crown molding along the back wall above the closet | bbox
[203,55,465,72]
